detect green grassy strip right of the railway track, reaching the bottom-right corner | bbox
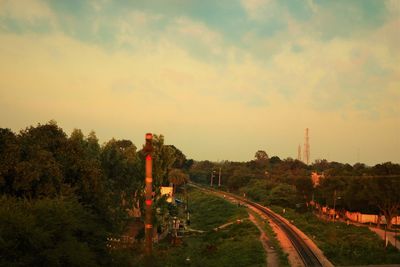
[273,207,400,265]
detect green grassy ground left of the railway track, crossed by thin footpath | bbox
[137,189,265,266]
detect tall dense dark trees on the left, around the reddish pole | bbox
[0,121,187,266]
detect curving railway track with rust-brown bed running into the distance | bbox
[190,183,324,266]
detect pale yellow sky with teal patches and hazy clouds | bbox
[0,0,400,165]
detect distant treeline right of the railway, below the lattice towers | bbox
[189,150,400,229]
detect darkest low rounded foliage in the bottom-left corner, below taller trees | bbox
[0,197,107,266]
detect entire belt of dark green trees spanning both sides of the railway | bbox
[0,121,400,266]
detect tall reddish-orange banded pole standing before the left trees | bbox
[143,133,153,257]
